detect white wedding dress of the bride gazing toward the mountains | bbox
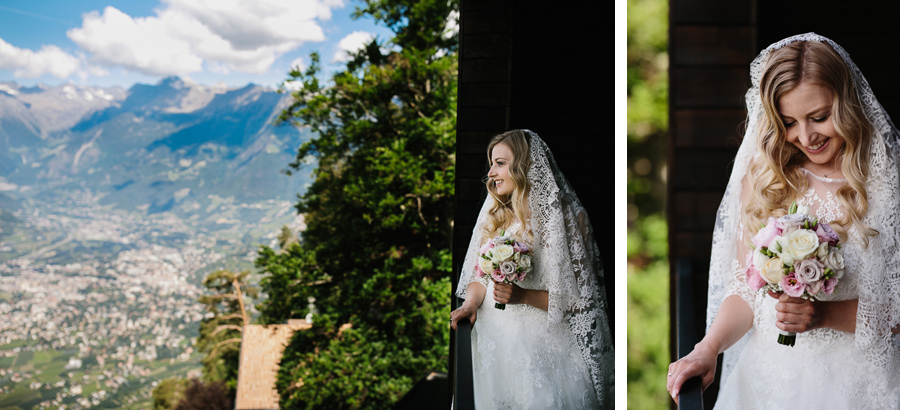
[472,224,600,410]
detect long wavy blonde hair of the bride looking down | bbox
[744,41,878,246]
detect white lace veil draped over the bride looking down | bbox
[706,33,900,397]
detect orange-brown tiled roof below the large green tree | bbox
[234,321,310,410]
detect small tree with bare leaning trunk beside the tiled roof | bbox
[197,270,259,398]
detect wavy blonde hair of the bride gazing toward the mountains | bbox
[482,130,534,240]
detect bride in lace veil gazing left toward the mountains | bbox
[451,130,614,409]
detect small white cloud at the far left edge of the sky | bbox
[0,39,80,78]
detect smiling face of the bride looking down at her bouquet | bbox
[778,81,844,172]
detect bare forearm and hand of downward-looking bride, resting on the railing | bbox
[666,295,753,400]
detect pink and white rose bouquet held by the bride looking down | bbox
[746,202,844,346]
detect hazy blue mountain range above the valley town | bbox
[0,77,308,223]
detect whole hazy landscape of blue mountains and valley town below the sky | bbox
[0,77,310,408]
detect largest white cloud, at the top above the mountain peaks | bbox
[67,0,343,76]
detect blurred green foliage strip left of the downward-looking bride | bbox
[627,0,671,410]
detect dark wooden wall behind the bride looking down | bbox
[667,0,900,408]
